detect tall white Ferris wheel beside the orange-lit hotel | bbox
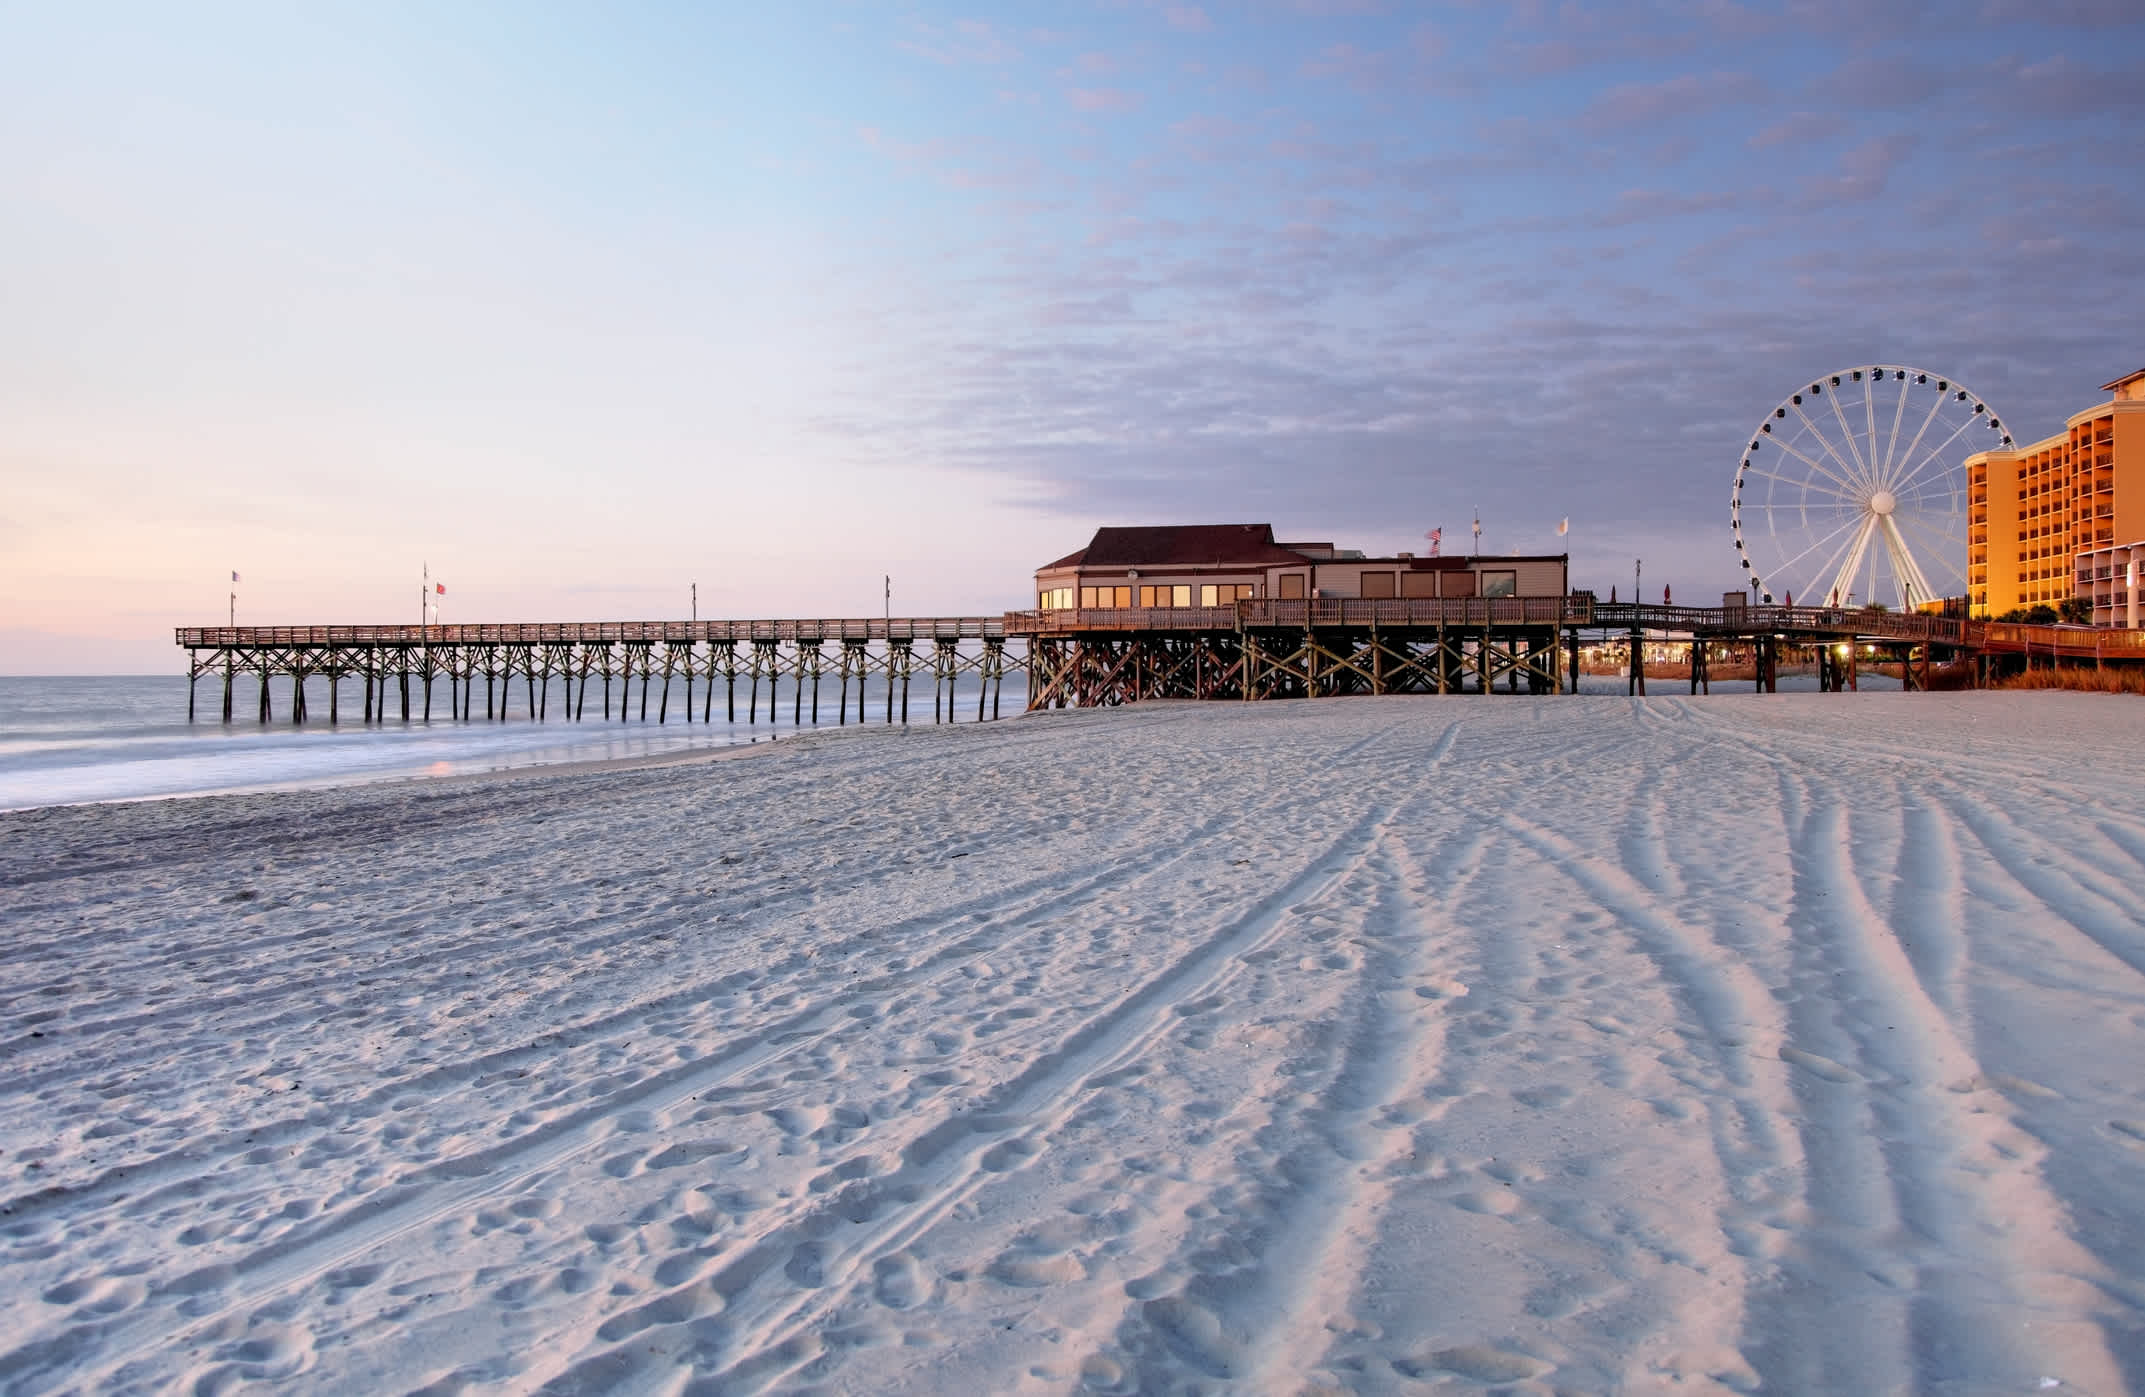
[1729,365,2012,612]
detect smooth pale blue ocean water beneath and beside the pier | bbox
[0,674,1025,809]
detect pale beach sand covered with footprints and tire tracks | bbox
[0,693,2145,1393]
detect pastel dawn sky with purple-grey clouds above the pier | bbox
[0,0,2145,674]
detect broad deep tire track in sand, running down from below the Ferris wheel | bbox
[1748,764,2121,1391]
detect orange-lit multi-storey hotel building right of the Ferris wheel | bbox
[1967,369,2145,627]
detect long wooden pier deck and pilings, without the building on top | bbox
[178,592,2145,725]
